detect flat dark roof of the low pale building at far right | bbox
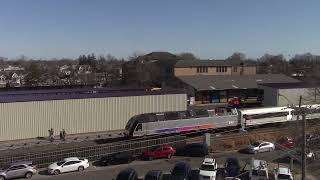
[259,82,320,89]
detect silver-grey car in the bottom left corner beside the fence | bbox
[0,161,37,180]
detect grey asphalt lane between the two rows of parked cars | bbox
[33,151,292,180]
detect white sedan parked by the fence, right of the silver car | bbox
[48,157,89,175]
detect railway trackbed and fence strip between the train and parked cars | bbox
[0,120,320,169]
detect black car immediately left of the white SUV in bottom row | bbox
[171,162,191,180]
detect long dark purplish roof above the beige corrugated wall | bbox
[0,88,185,103]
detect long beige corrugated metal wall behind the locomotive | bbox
[0,94,187,141]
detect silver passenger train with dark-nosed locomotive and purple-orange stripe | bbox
[124,104,320,137]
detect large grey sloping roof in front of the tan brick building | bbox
[177,74,301,91]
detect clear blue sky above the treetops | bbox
[0,0,320,58]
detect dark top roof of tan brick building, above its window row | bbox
[175,60,255,68]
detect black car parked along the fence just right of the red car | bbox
[177,143,209,157]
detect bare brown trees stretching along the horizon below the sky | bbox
[0,52,320,86]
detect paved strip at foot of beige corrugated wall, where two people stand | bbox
[0,130,123,151]
